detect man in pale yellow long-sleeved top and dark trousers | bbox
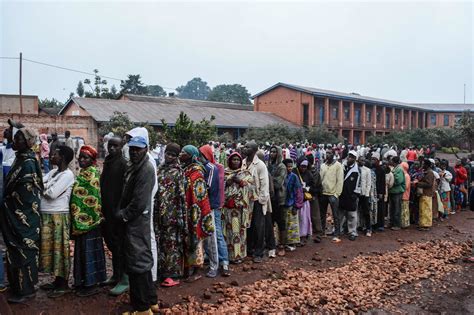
[320,149,344,243]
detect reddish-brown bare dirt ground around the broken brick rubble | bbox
[0,211,474,314]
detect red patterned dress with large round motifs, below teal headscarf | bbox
[184,163,214,268]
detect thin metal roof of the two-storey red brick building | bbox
[252,82,474,111]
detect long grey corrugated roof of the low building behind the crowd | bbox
[68,97,297,128]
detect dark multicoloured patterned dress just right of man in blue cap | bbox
[153,164,188,279]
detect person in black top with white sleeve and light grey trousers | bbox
[339,150,360,241]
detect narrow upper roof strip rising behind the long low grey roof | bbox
[124,94,253,111]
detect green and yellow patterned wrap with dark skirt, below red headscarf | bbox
[71,166,107,287]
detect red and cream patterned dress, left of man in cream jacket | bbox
[222,168,255,261]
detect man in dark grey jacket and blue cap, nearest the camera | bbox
[116,136,159,314]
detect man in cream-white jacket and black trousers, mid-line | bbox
[242,141,271,263]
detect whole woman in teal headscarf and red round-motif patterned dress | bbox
[179,145,215,282]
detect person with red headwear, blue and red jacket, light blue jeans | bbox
[199,145,230,278]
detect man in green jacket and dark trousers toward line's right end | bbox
[388,156,405,231]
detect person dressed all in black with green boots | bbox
[100,136,129,296]
